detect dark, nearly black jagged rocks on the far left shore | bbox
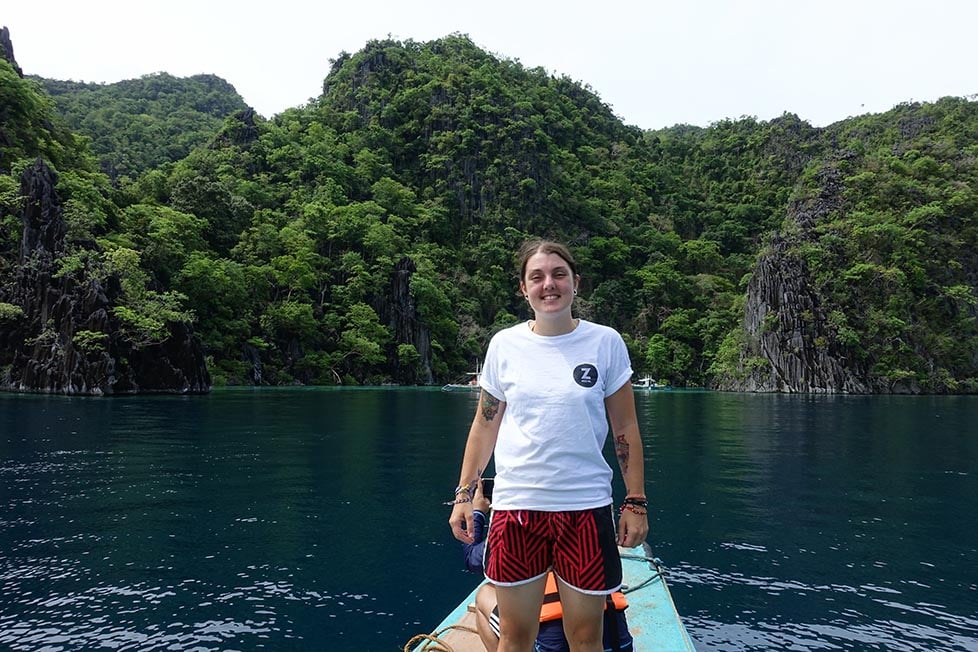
[0,159,210,396]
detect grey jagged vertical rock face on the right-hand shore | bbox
[717,165,875,394]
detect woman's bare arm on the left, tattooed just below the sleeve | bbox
[448,390,506,543]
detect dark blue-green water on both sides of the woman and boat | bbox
[0,389,978,652]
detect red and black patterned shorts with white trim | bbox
[484,505,621,594]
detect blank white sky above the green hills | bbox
[0,0,978,129]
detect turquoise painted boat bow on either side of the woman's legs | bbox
[405,543,696,652]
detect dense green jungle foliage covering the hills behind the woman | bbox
[0,36,978,391]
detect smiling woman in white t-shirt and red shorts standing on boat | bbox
[449,240,649,652]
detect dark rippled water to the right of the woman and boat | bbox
[640,393,978,650]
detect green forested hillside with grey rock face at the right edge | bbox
[721,98,978,392]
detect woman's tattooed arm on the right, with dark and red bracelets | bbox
[605,383,649,548]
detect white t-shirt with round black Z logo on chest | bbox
[479,319,632,511]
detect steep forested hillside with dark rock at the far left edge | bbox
[0,28,211,395]
